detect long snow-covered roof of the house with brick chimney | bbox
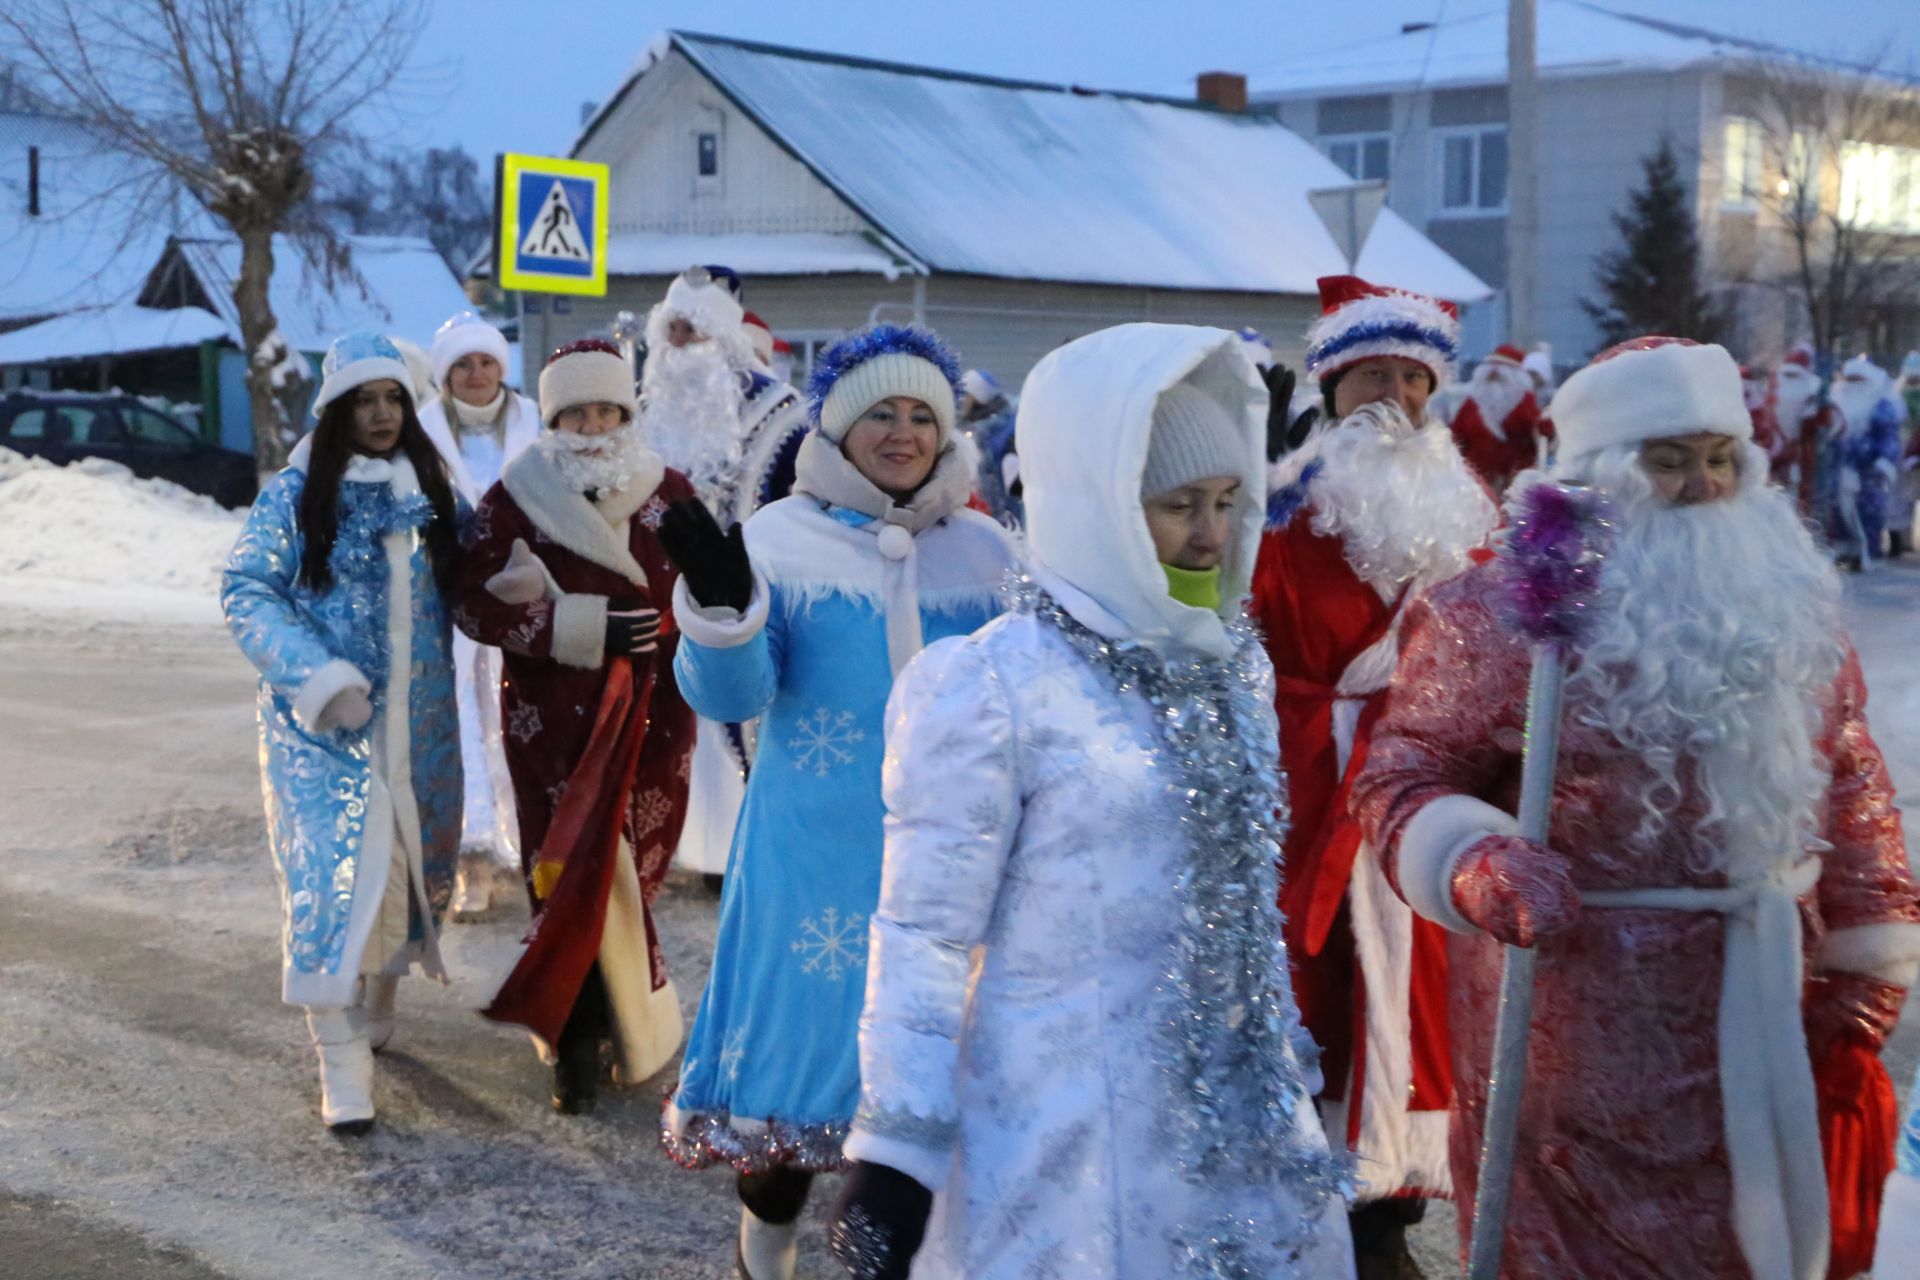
[574,33,1492,301]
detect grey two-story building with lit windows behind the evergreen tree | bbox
[1252,0,1920,365]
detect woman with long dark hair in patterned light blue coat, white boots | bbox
[221,334,465,1134]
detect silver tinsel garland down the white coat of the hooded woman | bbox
[1008,576,1354,1280]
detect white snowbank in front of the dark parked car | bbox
[0,449,246,597]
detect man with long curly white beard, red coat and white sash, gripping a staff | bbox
[1354,340,1920,1280]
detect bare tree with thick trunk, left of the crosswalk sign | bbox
[0,0,426,474]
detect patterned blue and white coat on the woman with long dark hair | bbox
[221,441,465,1007]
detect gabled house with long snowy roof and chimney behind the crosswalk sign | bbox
[518,33,1490,386]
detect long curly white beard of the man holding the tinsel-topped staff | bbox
[1543,445,1845,883]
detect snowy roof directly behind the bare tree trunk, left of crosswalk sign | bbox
[142,236,472,351]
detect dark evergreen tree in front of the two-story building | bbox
[1580,138,1726,345]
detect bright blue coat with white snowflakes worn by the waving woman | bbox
[664,495,1014,1171]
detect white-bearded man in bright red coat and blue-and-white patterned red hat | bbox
[1254,276,1496,1280]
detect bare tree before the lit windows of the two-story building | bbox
[1730,56,1920,353]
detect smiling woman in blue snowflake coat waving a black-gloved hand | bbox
[660,324,1014,1280]
